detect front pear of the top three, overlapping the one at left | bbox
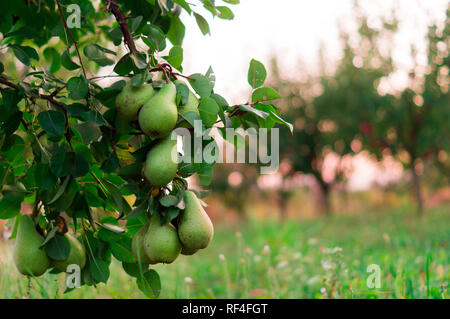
[138,83,178,138]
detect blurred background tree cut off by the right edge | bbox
[379,7,450,214]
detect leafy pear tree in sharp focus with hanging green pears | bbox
[0,0,286,297]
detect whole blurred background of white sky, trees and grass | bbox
[0,0,450,298]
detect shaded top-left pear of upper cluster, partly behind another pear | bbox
[116,84,155,121]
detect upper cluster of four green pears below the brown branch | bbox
[116,80,199,188]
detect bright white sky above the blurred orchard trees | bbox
[182,0,448,103]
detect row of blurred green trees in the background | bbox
[213,7,450,215]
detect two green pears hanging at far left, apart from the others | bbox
[13,215,86,277]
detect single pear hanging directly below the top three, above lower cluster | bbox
[144,136,178,188]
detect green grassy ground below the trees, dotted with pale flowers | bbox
[0,206,450,298]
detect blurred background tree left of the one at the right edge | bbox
[271,15,396,213]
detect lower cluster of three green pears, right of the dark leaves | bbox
[132,191,214,264]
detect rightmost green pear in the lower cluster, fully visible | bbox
[178,191,214,249]
